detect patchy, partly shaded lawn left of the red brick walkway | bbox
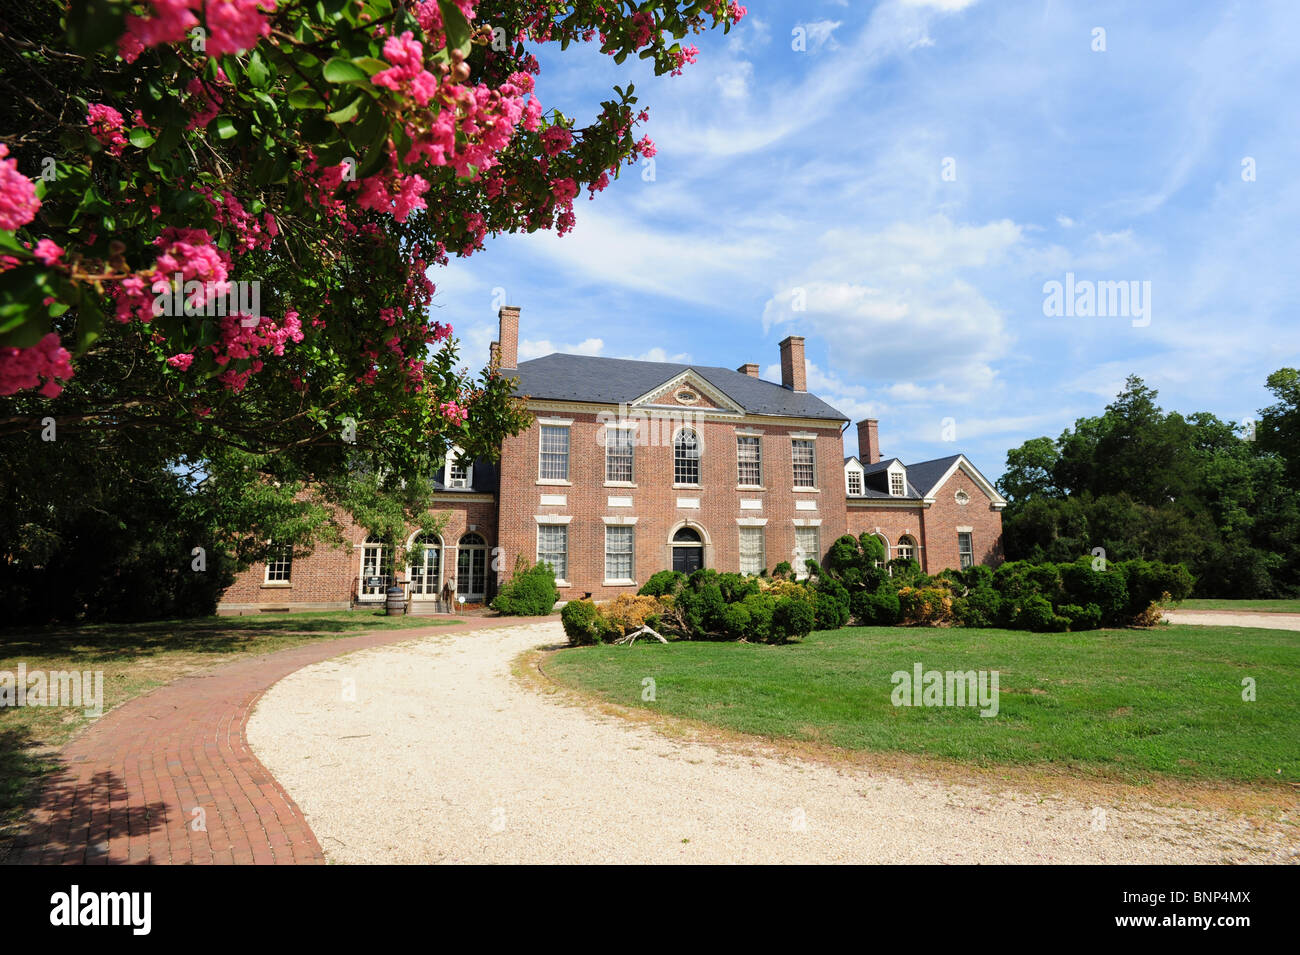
[0,611,459,832]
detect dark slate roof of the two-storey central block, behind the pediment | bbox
[506,353,849,421]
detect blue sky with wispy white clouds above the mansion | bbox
[433,0,1300,477]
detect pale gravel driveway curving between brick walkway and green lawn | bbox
[248,622,1297,863]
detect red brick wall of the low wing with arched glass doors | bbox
[217,495,497,613]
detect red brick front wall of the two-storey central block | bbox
[501,409,846,600]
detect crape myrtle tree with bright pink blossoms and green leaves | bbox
[0,0,745,621]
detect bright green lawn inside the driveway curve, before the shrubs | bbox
[546,626,1300,782]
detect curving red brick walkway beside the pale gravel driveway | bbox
[9,617,520,864]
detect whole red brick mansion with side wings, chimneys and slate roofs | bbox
[218,307,1005,613]
